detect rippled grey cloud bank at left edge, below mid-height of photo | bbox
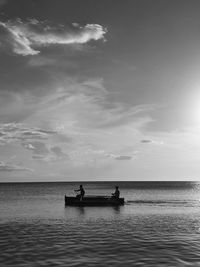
[0,123,71,162]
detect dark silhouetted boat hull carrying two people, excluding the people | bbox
[65,195,124,207]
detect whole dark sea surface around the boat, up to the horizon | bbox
[0,182,200,267]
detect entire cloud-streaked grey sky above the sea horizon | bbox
[0,0,200,182]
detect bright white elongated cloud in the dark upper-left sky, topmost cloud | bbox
[0,19,107,56]
